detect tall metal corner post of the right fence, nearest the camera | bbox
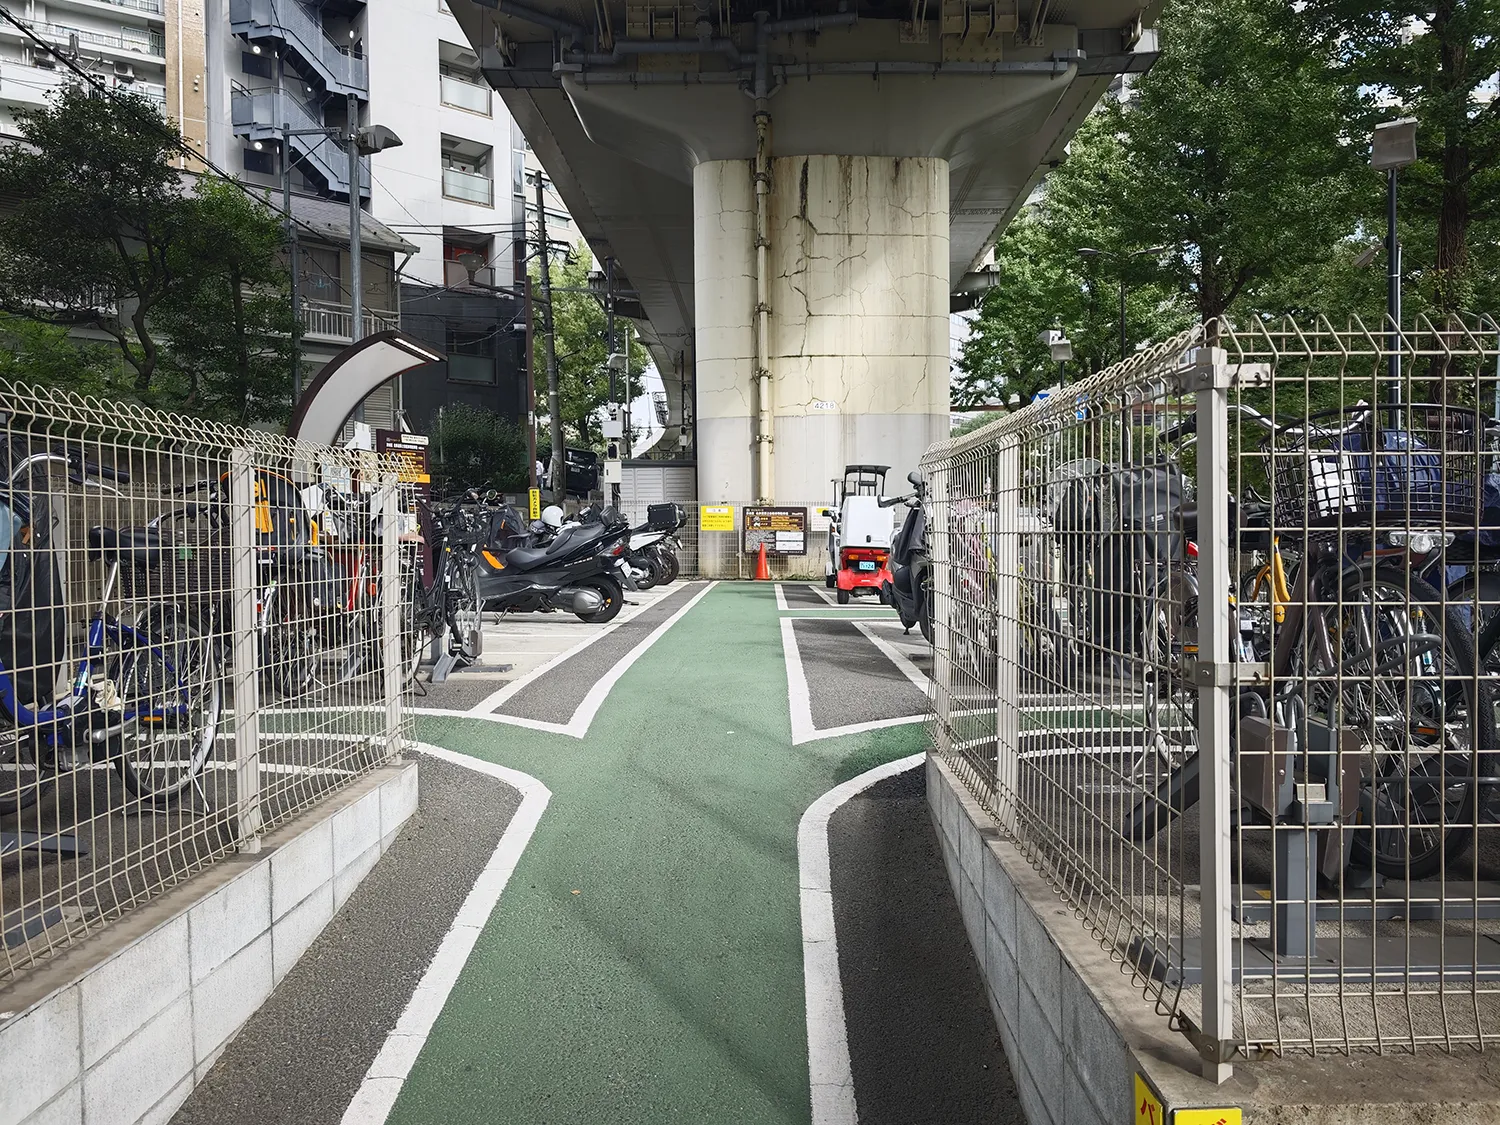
[1190,348,1235,1082]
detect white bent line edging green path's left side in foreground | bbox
[342,744,552,1125]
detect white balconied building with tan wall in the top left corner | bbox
[0,0,209,159]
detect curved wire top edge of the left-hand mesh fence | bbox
[0,380,402,474]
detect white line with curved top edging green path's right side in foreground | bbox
[797,753,927,1125]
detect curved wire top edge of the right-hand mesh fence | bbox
[923,314,1500,462]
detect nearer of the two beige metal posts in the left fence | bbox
[230,449,263,852]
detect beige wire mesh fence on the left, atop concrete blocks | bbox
[0,384,414,983]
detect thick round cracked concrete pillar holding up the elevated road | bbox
[693,156,948,504]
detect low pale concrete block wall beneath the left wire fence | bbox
[0,762,417,1125]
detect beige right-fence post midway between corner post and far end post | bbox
[990,432,1022,831]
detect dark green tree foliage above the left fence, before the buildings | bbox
[0,84,296,422]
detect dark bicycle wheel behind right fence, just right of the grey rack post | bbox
[1320,567,1497,879]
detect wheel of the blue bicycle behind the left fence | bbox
[105,606,224,797]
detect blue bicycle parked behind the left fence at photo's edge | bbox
[0,453,224,816]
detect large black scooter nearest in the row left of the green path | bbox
[473,509,630,624]
